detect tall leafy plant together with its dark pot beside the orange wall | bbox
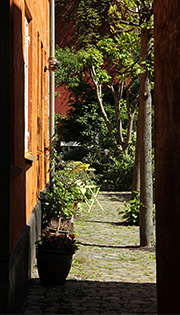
[37,159,95,284]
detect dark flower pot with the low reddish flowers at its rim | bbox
[37,229,78,285]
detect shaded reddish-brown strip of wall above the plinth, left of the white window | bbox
[10,4,26,251]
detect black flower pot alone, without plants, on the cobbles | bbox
[37,248,73,285]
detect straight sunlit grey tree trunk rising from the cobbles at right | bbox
[139,28,154,246]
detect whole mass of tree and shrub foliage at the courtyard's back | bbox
[56,0,153,190]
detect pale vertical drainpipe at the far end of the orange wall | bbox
[49,0,55,184]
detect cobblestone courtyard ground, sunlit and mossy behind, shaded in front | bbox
[23,192,157,314]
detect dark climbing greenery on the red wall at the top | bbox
[56,0,111,48]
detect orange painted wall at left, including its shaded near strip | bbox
[10,0,50,249]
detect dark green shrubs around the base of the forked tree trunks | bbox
[54,90,136,191]
